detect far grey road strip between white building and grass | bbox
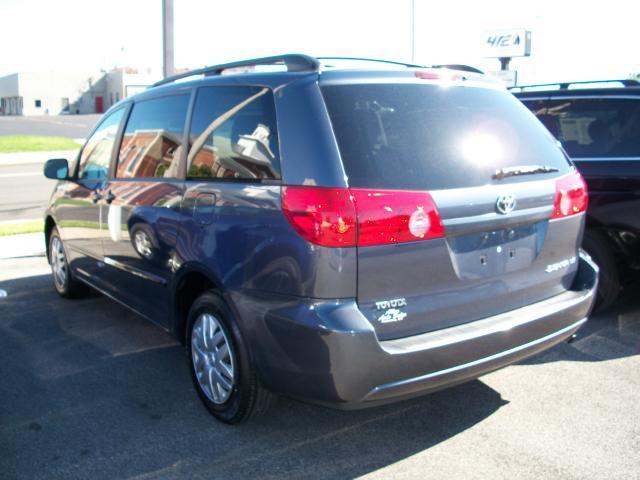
[0,114,100,138]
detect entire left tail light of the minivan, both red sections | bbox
[282,187,444,247]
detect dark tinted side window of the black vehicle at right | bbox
[525,98,640,158]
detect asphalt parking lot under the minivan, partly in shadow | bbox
[0,257,640,479]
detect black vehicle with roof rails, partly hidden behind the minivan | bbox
[512,80,640,308]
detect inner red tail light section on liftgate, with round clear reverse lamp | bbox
[351,189,444,246]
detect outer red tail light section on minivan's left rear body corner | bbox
[282,187,357,247]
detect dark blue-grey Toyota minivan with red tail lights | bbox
[45,55,597,423]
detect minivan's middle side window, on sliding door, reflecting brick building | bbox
[116,95,189,178]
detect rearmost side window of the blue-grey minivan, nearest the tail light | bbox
[187,87,280,180]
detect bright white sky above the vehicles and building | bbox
[0,0,640,83]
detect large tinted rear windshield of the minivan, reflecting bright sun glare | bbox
[322,84,569,190]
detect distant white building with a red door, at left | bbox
[0,68,161,115]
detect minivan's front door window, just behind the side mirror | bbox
[78,108,125,180]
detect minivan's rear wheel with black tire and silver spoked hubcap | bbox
[186,291,275,424]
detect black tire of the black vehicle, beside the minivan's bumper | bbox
[582,231,620,311]
